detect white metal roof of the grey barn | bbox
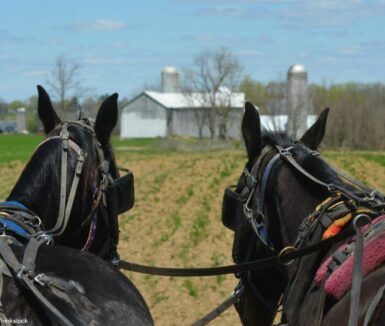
[144,90,245,109]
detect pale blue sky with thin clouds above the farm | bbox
[0,0,385,101]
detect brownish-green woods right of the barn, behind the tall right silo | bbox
[239,76,385,150]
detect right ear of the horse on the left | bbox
[95,93,118,144]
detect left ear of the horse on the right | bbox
[242,102,261,161]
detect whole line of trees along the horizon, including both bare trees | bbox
[0,48,385,150]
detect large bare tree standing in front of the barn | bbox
[185,48,242,138]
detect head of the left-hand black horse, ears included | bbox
[7,86,133,259]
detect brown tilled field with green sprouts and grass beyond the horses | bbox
[0,135,385,326]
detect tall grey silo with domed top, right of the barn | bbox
[287,64,308,139]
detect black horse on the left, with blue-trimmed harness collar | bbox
[0,87,153,325]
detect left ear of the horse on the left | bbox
[37,85,61,134]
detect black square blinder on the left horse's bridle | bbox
[107,171,135,215]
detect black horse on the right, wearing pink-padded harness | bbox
[223,103,385,325]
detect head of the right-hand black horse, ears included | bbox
[222,103,340,325]
